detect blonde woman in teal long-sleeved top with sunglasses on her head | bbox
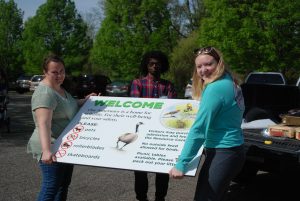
[169,47,245,201]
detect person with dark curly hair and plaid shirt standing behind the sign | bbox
[130,51,177,201]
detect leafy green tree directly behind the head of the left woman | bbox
[23,0,92,74]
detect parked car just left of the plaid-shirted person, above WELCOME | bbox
[106,80,131,97]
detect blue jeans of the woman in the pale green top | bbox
[38,161,73,201]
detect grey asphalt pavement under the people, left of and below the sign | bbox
[0,92,196,201]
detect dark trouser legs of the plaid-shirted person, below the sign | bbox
[134,171,169,201]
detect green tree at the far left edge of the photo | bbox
[0,0,23,77]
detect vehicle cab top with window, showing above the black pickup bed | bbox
[245,72,287,85]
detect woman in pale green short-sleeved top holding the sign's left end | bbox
[27,55,96,201]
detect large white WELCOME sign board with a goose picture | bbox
[53,96,202,176]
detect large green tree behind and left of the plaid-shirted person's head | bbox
[91,0,178,80]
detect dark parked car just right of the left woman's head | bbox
[74,75,111,98]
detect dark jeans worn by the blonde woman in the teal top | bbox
[194,146,245,201]
